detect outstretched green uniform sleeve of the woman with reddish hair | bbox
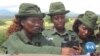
[2,36,61,54]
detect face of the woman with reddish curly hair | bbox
[21,17,43,34]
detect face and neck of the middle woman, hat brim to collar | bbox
[51,14,65,34]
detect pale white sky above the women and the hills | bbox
[0,0,100,14]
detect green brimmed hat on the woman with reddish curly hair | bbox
[15,3,45,17]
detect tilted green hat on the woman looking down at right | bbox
[78,11,98,29]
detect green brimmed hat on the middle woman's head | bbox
[48,2,69,16]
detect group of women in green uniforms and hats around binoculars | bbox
[2,2,100,55]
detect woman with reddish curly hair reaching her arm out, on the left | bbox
[2,3,61,54]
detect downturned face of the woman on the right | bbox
[78,24,93,38]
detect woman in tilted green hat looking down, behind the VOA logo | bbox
[73,11,98,54]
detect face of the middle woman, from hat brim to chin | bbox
[52,14,65,29]
